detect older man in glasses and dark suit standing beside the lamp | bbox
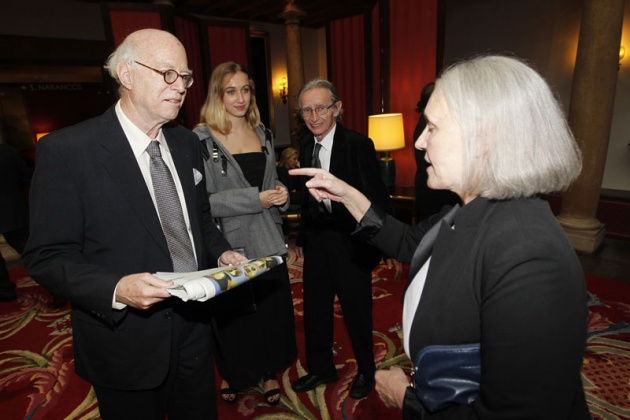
[293,79,393,399]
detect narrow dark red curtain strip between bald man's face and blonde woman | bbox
[175,17,207,129]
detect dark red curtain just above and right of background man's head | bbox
[329,15,367,135]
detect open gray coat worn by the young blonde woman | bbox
[193,124,289,258]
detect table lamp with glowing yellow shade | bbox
[368,113,405,192]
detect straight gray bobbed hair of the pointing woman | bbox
[434,56,582,200]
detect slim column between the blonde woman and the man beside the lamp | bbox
[280,0,305,149]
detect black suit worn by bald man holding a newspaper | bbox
[23,107,235,390]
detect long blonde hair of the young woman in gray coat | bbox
[197,61,260,134]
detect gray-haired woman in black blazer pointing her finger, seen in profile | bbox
[290,56,590,419]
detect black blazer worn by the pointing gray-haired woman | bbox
[372,198,588,419]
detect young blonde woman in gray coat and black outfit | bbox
[194,62,297,405]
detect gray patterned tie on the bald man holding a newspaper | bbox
[147,140,197,273]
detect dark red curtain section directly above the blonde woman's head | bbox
[207,26,250,69]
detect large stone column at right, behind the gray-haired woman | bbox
[558,0,624,254]
